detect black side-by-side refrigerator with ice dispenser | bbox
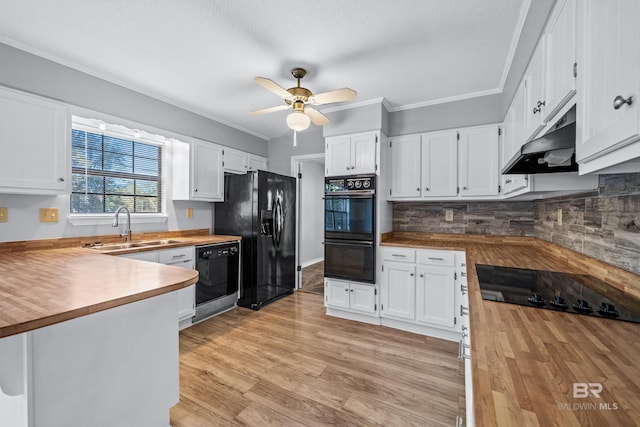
[214,170,296,310]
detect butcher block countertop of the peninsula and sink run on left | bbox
[0,229,240,338]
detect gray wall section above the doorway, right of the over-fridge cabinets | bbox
[268,130,324,175]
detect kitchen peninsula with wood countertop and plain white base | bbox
[0,241,198,426]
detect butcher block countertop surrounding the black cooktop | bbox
[381,232,640,427]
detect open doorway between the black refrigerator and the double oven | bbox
[291,153,324,293]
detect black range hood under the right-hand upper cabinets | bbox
[502,106,578,175]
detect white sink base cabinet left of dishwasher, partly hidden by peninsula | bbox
[120,246,196,329]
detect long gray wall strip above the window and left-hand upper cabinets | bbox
[0,43,267,156]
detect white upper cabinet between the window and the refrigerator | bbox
[172,139,224,202]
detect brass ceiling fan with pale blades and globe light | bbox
[251,68,357,131]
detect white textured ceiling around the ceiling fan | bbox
[0,0,529,139]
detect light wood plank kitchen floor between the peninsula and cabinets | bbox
[171,292,464,427]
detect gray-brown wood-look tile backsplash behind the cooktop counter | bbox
[393,173,640,274]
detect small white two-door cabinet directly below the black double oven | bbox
[324,278,378,323]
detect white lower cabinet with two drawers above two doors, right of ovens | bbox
[380,247,466,341]
